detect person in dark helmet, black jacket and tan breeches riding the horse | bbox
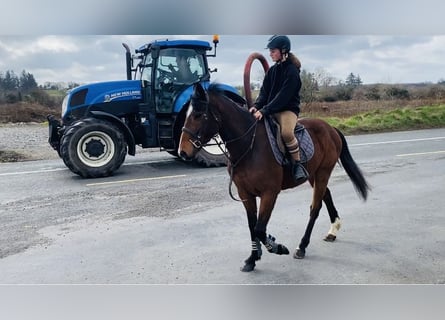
[249,35,307,182]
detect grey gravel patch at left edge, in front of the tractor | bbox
[0,123,59,162]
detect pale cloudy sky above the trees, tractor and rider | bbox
[0,35,445,85]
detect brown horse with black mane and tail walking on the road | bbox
[179,84,369,271]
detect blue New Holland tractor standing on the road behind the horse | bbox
[48,36,245,178]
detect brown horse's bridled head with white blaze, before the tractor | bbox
[178,83,219,160]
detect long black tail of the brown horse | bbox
[335,128,370,200]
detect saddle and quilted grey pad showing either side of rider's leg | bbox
[264,116,314,166]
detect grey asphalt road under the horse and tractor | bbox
[0,129,445,284]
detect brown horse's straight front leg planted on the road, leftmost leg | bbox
[240,194,262,272]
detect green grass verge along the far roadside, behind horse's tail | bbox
[322,105,445,134]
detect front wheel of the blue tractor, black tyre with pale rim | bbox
[60,118,127,178]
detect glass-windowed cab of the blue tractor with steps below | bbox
[124,36,219,153]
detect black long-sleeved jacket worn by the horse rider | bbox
[254,59,301,116]
